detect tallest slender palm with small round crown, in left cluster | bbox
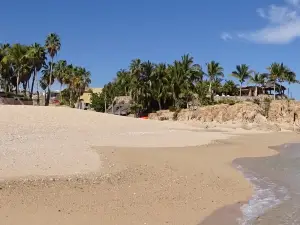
[45,33,61,105]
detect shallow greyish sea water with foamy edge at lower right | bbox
[233,144,300,225]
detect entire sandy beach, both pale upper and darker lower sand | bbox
[0,106,299,225]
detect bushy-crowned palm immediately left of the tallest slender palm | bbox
[27,43,47,98]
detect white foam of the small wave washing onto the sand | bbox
[237,166,290,225]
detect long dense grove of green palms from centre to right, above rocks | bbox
[92,55,297,112]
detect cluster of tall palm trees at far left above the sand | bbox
[0,33,91,106]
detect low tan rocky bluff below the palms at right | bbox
[149,100,300,131]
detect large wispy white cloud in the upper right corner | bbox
[225,0,300,44]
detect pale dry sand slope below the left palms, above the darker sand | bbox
[0,105,237,179]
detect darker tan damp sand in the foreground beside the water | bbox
[0,133,299,225]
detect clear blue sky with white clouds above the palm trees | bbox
[0,0,300,99]
